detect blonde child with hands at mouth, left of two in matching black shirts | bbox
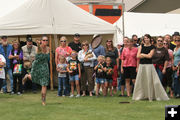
[94,55,105,96]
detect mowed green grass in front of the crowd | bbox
[0,91,180,120]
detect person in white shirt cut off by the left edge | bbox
[0,54,6,90]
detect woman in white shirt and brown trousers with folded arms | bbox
[78,41,96,96]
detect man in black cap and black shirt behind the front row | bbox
[68,33,81,52]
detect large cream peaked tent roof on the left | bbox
[0,0,115,35]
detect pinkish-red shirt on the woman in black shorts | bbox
[121,47,138,67]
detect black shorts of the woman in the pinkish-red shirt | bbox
[123,67,136,79]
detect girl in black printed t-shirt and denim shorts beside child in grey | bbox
[67,51,81,97]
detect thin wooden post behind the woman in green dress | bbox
[49,35,54,90]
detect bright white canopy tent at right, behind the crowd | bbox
[114,12,180,44]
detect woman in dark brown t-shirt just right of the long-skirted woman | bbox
[152,36,169,83]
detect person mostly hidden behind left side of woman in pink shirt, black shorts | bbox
[119,37,129,97]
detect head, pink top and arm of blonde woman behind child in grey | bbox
[55,36,72,65]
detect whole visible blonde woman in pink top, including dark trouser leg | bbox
[55,36,72,95]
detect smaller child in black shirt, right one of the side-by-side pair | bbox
[104,57,113,96]
